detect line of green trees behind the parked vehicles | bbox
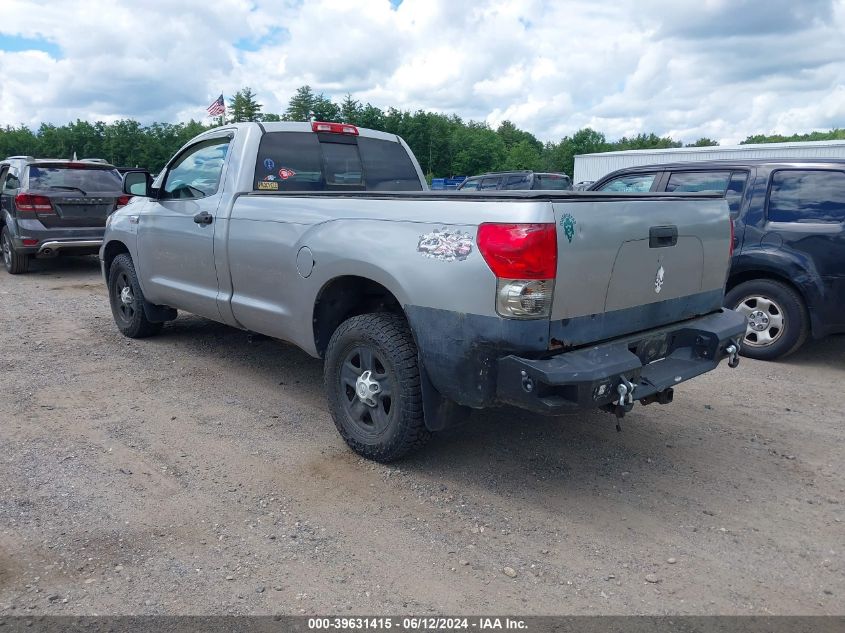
[0,86,845,178]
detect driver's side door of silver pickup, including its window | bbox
[137,135,231,320]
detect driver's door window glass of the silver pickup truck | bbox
[162,138,229,200]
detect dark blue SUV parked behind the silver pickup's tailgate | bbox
[591,159,845,360]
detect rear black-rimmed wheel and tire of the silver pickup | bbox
[324,312,431,462]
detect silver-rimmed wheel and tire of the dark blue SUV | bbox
[725,279,810,360]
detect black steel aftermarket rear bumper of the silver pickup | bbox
[496,309,746,415]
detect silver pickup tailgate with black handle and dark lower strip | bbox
[551,198,731,346]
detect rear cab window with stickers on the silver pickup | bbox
[253,132,422,191]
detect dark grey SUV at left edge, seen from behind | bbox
[0,156,129,274]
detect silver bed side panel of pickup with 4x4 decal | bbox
[227,195,553,355]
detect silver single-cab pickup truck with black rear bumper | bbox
[100,122,745,461]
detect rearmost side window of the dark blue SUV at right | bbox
[768,170,845,223]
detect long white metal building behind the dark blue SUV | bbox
[572,140,845,183]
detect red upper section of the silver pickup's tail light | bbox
[476,224,557,279]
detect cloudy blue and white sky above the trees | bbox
[0,0,845,144]
